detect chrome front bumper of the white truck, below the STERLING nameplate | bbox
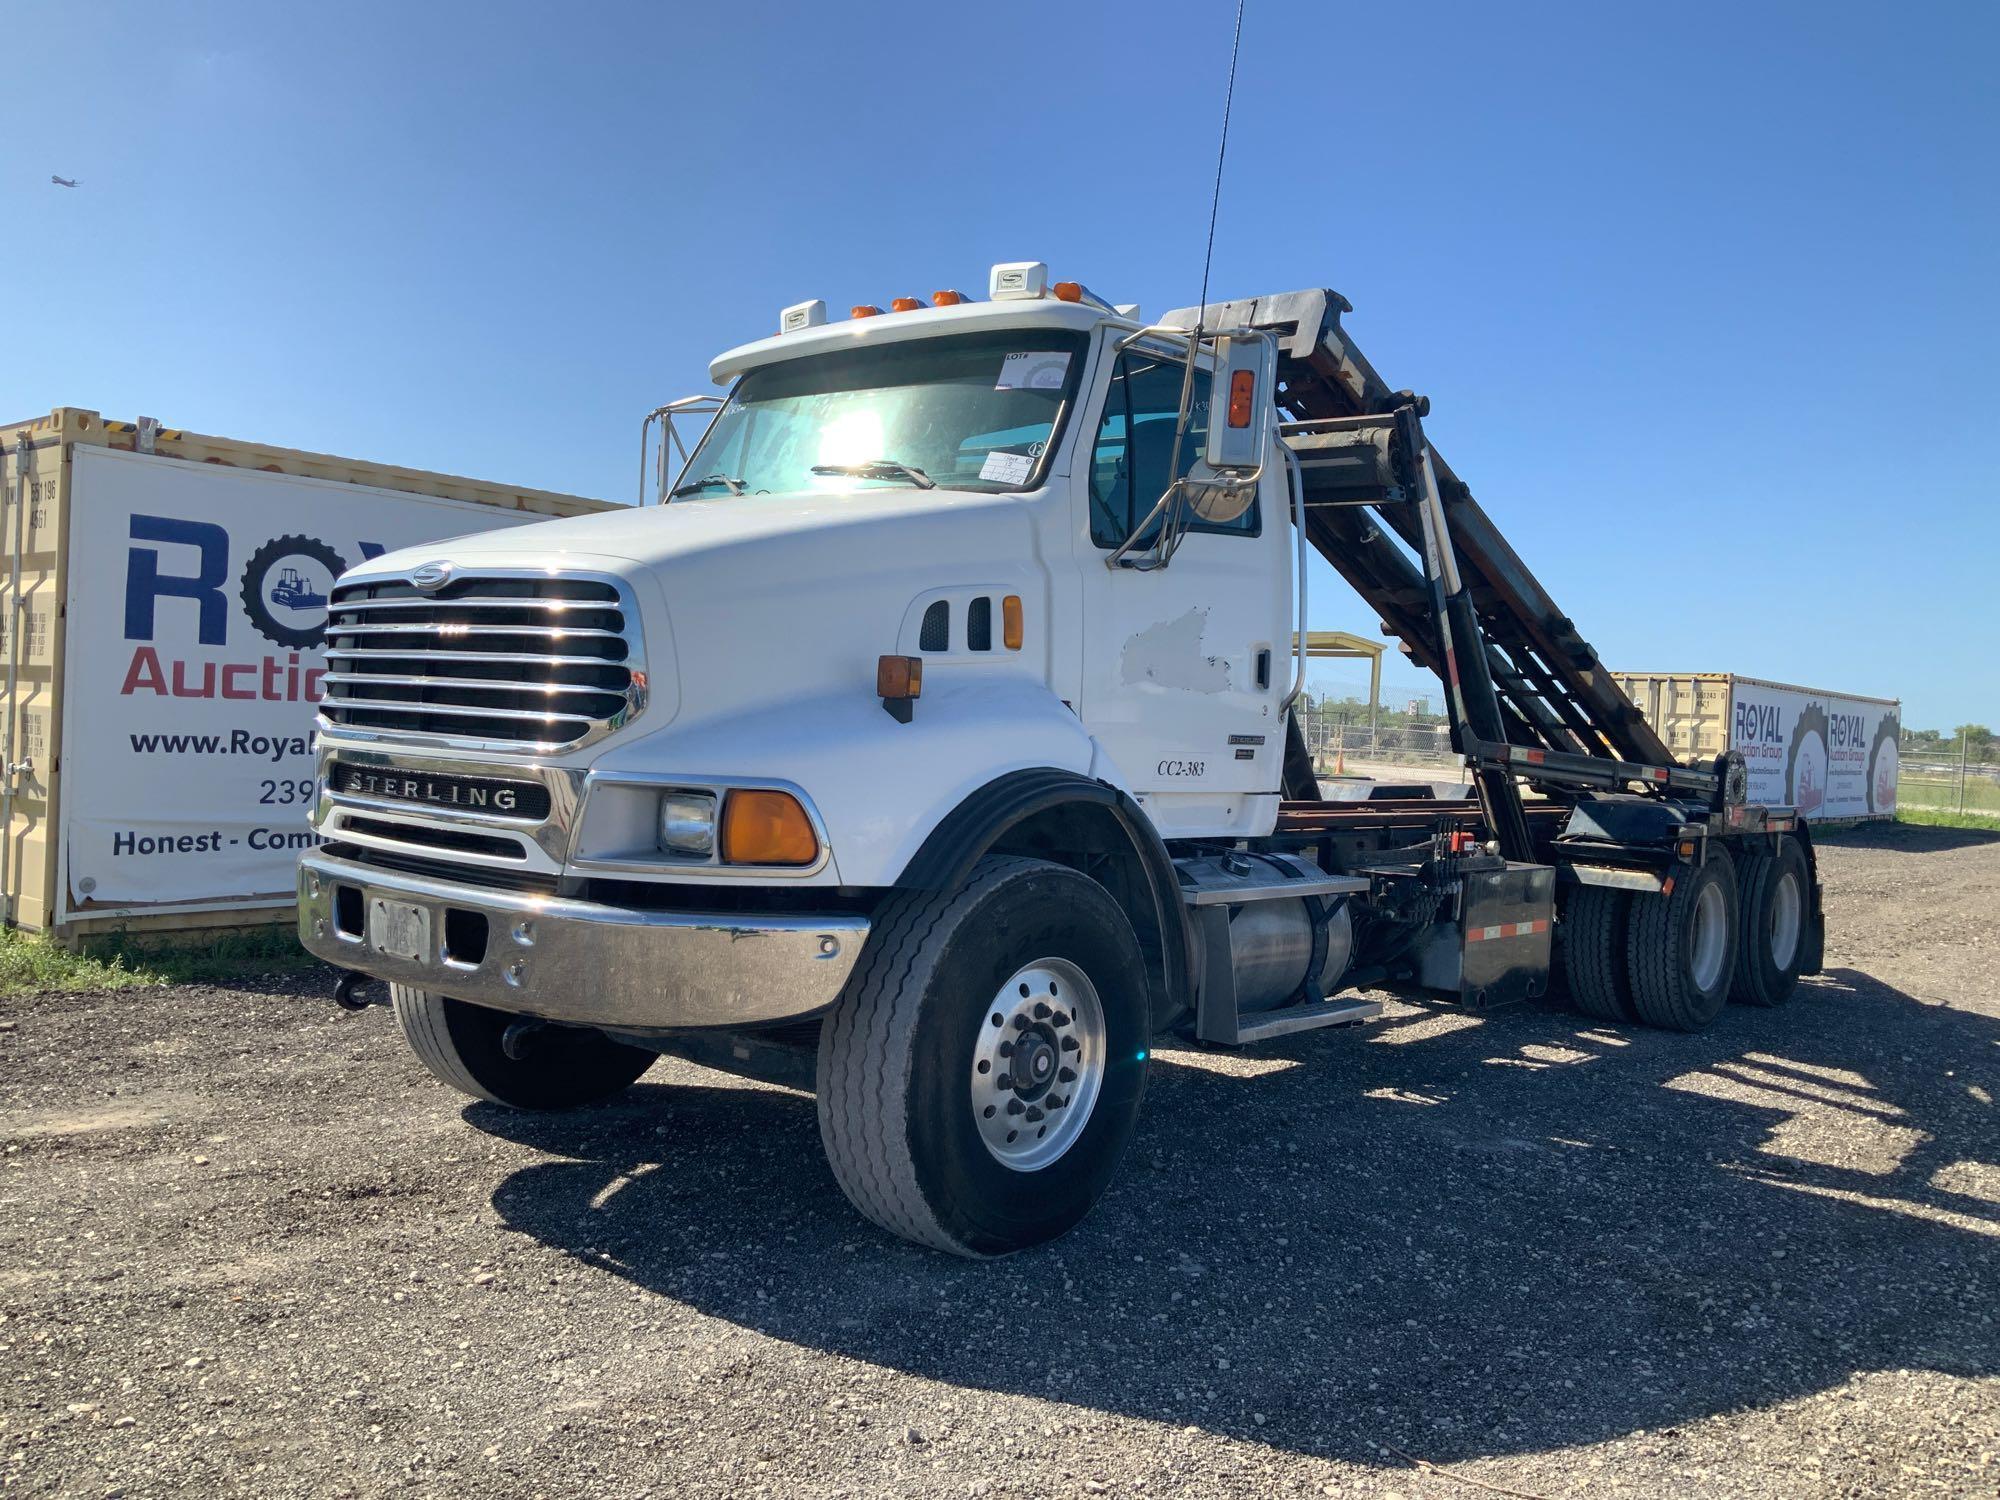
[298,852,868,1030]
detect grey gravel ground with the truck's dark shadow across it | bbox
[0,828,2000,1500]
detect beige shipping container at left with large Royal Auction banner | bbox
[0,406,610,940]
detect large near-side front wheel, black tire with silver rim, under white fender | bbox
[818,856,1150,1256]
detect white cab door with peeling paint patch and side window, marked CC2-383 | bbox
[1078,344,1292,838]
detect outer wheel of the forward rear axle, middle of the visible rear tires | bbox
[1626,846,1736,1032]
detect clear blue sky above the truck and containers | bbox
[0,0,2000,726]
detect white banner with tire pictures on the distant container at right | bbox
[1730,678,1902,818]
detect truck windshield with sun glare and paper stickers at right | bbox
[674,328,1088,500]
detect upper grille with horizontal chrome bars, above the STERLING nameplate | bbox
[320,576,646,750]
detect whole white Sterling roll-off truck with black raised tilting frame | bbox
[298,262,1824,1256]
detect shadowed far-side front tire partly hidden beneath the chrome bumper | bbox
[390,984,658,1110]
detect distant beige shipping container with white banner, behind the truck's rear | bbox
[1612,672,1902,822]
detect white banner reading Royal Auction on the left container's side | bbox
[62,446,542,916]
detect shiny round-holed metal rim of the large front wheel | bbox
[970,958,1104,1172]
